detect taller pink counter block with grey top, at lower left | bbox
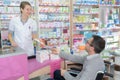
[0,48,28,80]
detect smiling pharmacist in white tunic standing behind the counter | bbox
[8,1,37,56]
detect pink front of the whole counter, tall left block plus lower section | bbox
[0,54,61,80]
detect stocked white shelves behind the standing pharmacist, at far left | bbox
[0,0,34,50]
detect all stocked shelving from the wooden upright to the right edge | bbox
[70,0,120,52]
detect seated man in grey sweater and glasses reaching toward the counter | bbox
[48,35,105,80]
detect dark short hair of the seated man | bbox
[91,35,105,53]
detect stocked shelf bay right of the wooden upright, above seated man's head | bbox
[71,0,99,52]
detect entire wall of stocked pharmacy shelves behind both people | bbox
[0,0,120,80]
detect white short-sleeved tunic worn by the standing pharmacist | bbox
[9,16,37,56]
